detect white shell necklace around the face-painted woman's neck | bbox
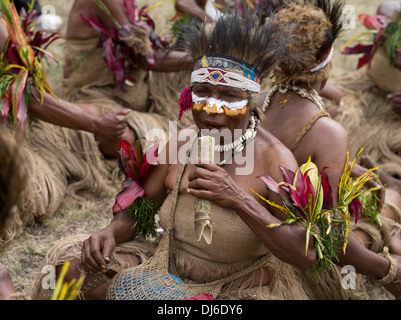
[199,113,260,166]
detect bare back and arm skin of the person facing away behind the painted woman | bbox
[259,80,401,299]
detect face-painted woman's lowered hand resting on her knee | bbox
[80,228,116,273]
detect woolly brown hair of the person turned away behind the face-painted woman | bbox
[275,0,344,83]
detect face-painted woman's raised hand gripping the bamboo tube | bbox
[188,163,246,208]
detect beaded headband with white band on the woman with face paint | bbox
[191,54,260,93]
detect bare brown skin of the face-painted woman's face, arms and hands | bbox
[62,84,316,298]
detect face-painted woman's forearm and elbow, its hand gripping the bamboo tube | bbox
[234,195,316,271]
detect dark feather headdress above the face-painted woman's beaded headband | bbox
[174,8,291,79]
